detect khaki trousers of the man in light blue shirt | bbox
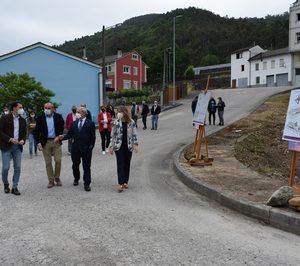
[43,139,62,182]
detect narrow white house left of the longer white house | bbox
[231,45,264,88]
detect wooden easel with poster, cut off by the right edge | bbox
[282,90,300,191]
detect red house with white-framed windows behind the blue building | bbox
[95,50,148,91]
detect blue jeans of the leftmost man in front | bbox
[1,144,22,188]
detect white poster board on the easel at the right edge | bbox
[282,90,300,142]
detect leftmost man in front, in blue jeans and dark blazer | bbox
[0,102,26,196]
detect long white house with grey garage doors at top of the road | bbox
[249,47,292,87]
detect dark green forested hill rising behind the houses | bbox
[55,7,289,81]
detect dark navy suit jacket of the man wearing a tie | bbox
[64,119,96,153]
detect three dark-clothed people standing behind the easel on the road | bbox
[191,96,225,126]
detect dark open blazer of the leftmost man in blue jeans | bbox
[0,113,26,151]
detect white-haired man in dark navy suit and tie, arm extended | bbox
[60,107,96,191]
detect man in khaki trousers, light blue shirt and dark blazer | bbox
[35,103,64,188]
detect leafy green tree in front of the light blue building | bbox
[0,72,58,113]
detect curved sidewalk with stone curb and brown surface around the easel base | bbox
[173,146,300,235]
